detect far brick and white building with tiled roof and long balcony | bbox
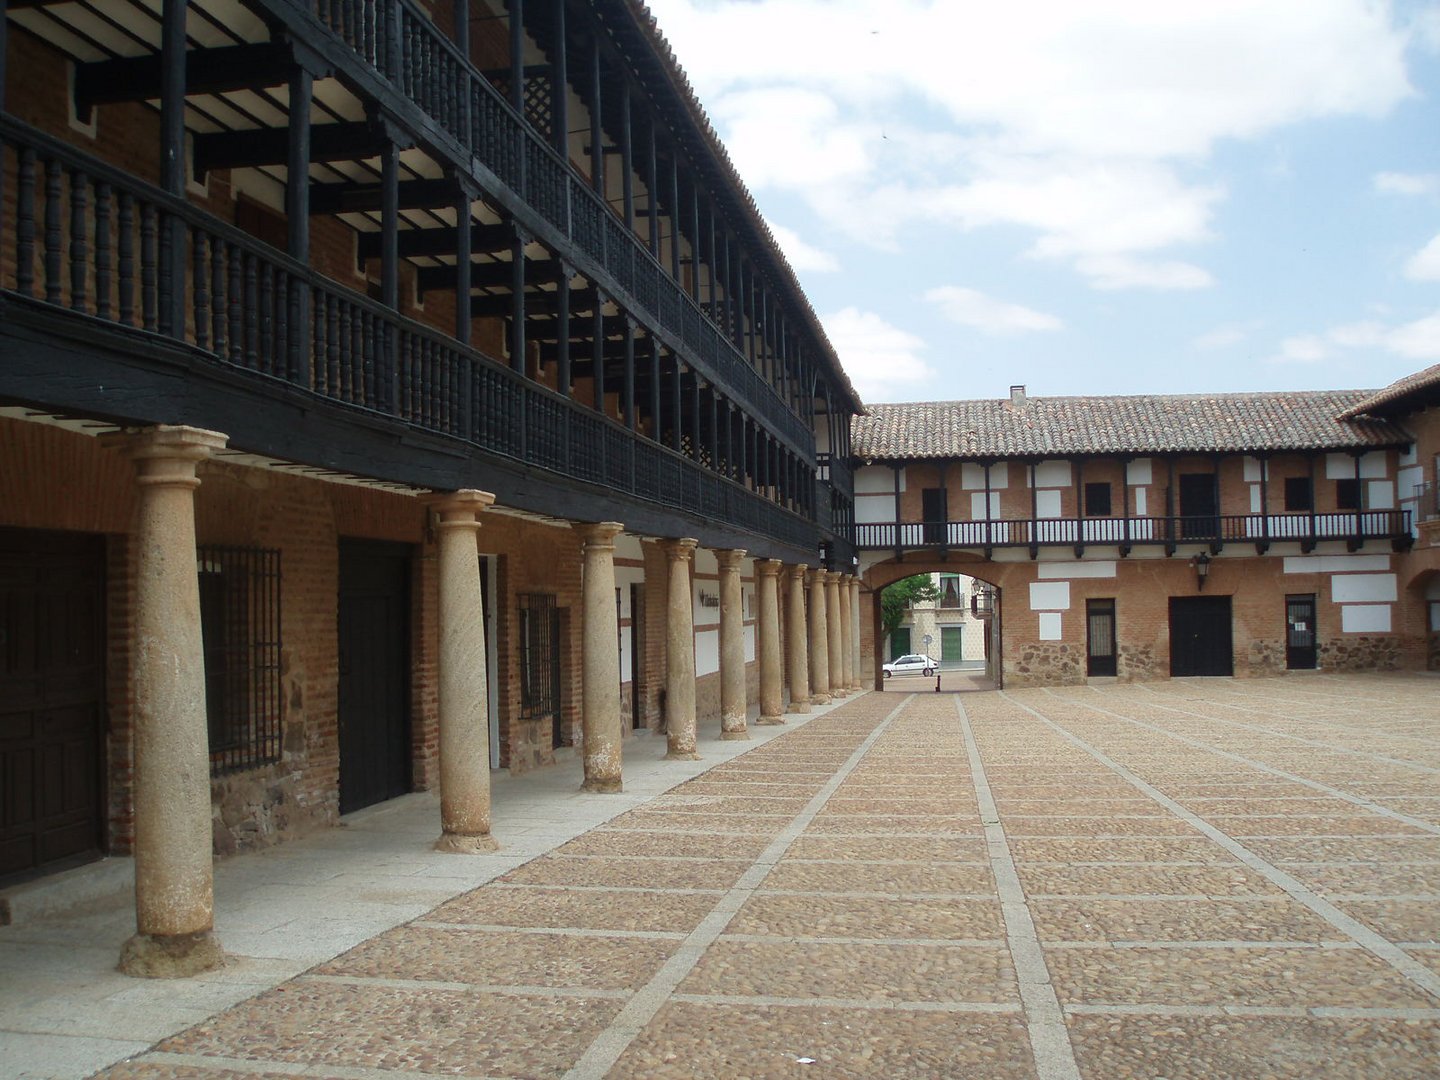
[854,369,1440,685]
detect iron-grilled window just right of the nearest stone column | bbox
[196,546,281,776]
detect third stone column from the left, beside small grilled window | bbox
[575,521,625,795]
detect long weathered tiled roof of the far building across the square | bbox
[851,390,1410,461]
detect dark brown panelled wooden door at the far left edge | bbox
[0,528,105,883]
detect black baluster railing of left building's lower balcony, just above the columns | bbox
[0,117,815,547]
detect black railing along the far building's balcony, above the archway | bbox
[855,510,1410,549]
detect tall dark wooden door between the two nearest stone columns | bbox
[338,540,412,814]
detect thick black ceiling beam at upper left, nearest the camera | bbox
[75,42,295,122]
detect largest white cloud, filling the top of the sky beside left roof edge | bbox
[651,0,1424,289]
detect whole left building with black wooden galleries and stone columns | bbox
[0,0,861,969]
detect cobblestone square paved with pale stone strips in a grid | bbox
[92,675,1440,1080]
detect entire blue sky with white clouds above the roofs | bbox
[649,0,1440,402]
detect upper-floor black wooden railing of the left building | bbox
[298,0,815,456]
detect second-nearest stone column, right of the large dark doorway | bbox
[425,488,500,855]
